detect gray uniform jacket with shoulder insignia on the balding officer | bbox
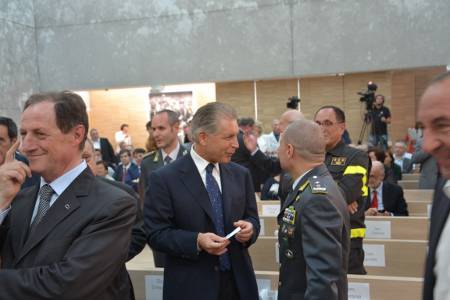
[278,165,350,300]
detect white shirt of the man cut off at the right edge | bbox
[434,180,450,300]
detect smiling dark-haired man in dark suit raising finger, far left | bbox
[0,92,136,300]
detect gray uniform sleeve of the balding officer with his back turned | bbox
[300,195,346,300]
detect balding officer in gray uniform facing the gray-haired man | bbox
[278,120,350,300]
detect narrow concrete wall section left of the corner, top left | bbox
[0,0,39,122]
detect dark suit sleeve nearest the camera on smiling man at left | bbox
[0,193,136,299]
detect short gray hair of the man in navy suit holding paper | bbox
[191,102,237,142]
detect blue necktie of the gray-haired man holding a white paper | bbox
[206,164,231,271]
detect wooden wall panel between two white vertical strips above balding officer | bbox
[256,79,297,133]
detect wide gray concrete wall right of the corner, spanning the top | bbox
[35,0,450,90]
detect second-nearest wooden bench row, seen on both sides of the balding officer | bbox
[250,237,427,277]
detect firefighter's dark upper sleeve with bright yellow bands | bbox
[337,152,369,206]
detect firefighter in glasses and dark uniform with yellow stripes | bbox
[314,106,370,274]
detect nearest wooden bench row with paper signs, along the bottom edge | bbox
[128,268,423,300]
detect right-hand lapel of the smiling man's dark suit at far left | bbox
[15,169,94,264]
